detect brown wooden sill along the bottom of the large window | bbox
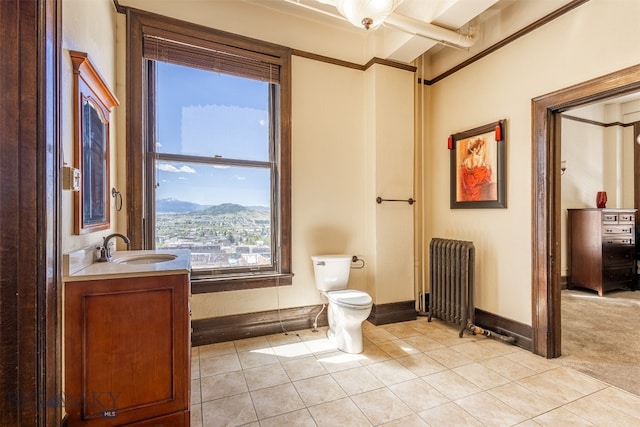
[191,273,293,294]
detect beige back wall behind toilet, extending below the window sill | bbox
[192,56,414,319]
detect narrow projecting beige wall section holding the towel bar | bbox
[365,65,415,304]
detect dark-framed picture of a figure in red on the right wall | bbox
[449,119,507,209]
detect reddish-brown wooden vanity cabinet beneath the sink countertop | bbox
[64,273,191,427]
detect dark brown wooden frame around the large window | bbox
[126,10,293,293]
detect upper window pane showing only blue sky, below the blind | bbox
[156,61,269,161]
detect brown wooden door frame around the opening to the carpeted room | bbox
[531,65,640,358]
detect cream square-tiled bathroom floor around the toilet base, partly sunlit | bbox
[191,318,640,427]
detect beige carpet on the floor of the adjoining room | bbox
[558,289,640,396]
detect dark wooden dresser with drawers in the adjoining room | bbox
[567,208,636,296]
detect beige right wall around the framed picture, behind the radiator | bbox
[424,0,640,325]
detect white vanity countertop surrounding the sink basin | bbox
[64,249,191,282]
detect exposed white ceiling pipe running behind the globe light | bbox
[283,0,477,49]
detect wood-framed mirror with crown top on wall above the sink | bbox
[69,51,119,234]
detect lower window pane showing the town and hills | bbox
[155,161,273,269]
